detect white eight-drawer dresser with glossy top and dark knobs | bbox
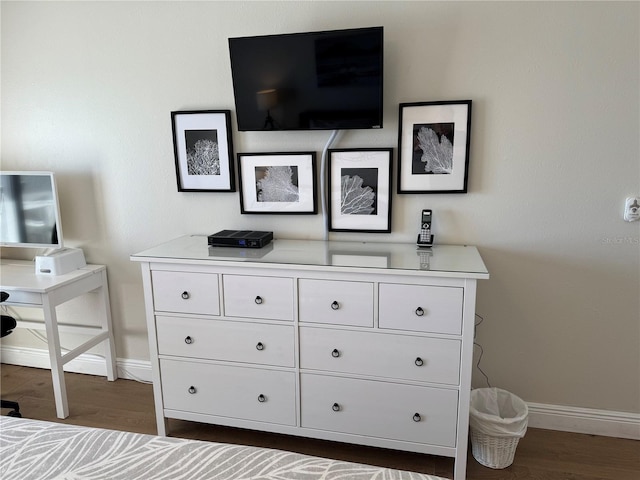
[131,235,489,480]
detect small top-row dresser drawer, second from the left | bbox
[222,275,293,320]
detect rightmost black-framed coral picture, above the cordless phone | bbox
[398,100,471,193]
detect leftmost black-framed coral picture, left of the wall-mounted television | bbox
[171,110,236,192]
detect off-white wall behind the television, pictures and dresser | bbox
[1,1,640,412]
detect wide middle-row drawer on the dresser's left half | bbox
[156,315,295,367]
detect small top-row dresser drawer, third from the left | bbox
[298,279,373,327]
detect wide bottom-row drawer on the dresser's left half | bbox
[160,359,296,425]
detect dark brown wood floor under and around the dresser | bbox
[1,364,640,480]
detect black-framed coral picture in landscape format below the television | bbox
[238,152,318,214]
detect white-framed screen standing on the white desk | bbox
[0,172,63,249]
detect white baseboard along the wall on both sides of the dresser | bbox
[0,346,640,440]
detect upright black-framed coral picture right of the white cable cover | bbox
[327,148,393,233]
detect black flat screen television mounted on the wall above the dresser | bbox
[229,27,384,131]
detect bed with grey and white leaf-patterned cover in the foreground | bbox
[0,417,444,480]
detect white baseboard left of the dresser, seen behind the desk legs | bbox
[0,345,151,383]
